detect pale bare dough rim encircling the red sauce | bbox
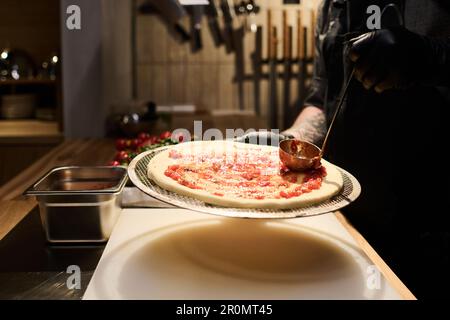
[147,141,344,209]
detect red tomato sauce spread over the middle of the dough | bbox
[164,149,327,200]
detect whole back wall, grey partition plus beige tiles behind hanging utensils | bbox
[61,0,320,138]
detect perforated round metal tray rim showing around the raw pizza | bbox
[128,146,361,219]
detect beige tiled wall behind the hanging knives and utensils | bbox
[137,0,319,127]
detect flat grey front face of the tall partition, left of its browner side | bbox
[60,0,103,138]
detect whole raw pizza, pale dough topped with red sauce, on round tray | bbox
[148,141,343,209]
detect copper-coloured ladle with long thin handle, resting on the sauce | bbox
[279,69,355,171]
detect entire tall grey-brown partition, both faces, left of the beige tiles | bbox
[61,0,132,138]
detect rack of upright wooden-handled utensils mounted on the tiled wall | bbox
[234,10,315,129]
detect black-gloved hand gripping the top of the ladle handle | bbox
[349,27,450,92]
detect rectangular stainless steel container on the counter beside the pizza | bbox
[25,167,127,243]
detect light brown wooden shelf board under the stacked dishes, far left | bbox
[0,119,62,139]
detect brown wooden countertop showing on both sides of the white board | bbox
[0,139,415,300]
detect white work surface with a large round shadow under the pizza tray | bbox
[84,208,400,300]
